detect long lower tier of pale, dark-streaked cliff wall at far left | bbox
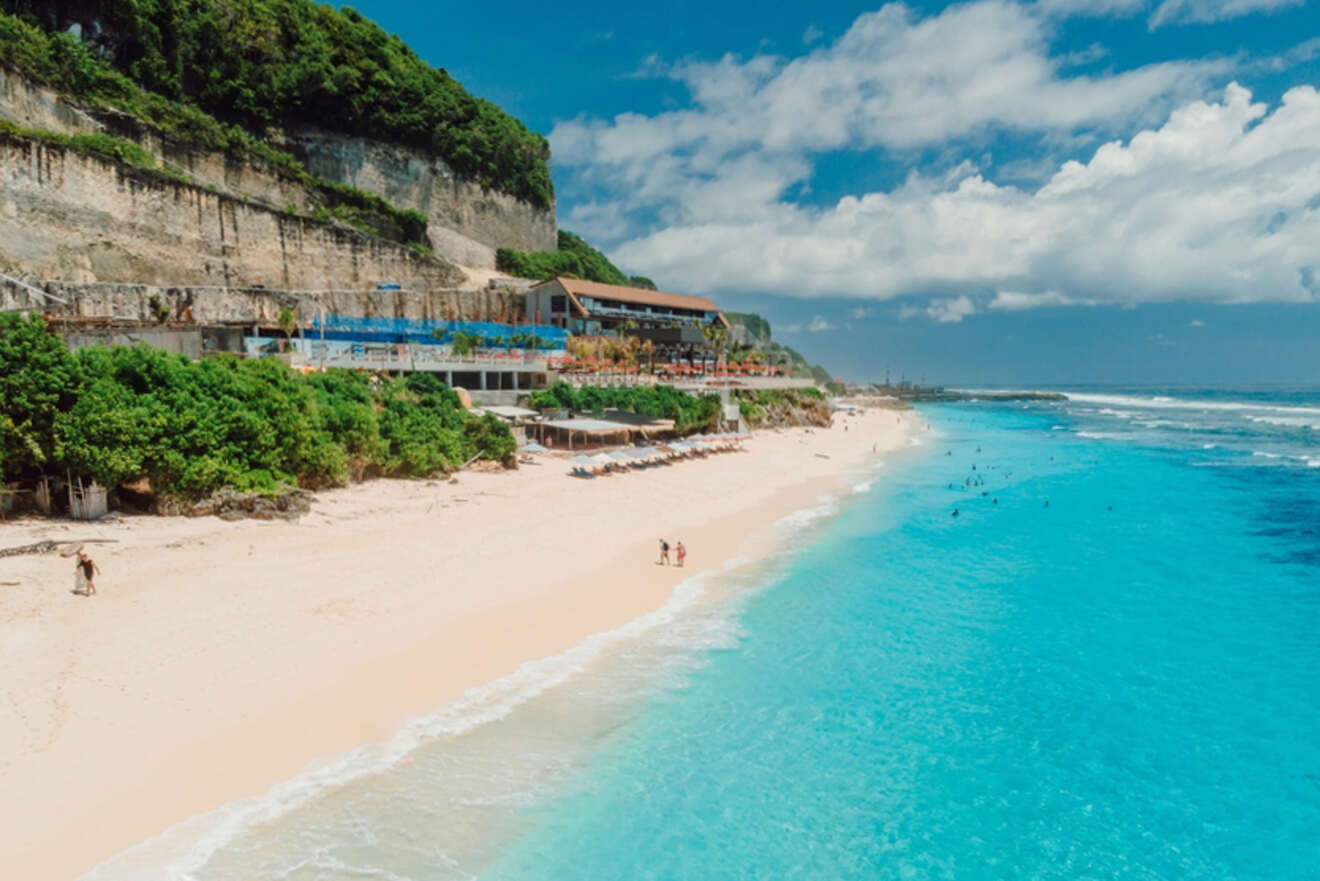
[0,135,465,291]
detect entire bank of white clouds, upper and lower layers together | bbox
[552,1,1320,311]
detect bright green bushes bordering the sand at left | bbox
[0,316,516,498]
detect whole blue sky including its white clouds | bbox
[358,0,1320,384]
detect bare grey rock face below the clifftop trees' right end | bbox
[286,132,558,268]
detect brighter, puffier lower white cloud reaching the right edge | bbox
[567,85,1320,309]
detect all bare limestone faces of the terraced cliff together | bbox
[0,65,556,282]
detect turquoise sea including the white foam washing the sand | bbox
[91,391,1320,881]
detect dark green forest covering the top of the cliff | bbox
[0,0,554,207]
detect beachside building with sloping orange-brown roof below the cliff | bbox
[527,279,729,349]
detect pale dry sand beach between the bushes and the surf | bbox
[0,409,919,878]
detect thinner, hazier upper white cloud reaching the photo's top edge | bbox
[550,0,1226,239]
